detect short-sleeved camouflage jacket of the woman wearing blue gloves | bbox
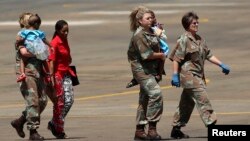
[169,32,212,88]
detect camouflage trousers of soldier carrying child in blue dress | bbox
[20,76,48,130]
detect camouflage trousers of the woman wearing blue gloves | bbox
[173,88,217,127]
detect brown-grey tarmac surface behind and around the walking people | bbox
[0,0,250,141]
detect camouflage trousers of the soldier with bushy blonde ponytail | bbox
[136,76,163,125]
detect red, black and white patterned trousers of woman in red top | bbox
[52,75,74,133]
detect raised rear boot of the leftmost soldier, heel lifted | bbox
[10,115,26,138]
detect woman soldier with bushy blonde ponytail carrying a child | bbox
[127,6,165,140]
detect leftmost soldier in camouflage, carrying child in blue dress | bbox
[11,13,48,140]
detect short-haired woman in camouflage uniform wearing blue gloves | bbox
[170,12,230,138]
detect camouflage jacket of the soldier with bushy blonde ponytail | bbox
[127,27,160,79]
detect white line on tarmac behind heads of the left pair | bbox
[0,20,107,26]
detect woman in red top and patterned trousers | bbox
[48,20,74,139]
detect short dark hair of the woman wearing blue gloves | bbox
[181,12,199,30]
